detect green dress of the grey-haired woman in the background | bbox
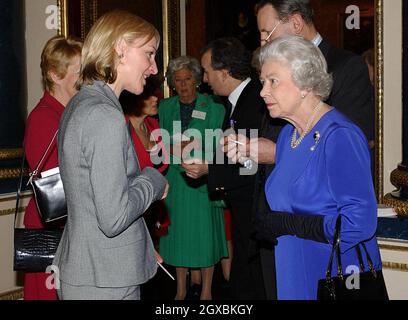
[159,94,228,268]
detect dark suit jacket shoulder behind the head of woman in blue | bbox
[319,39,375,140]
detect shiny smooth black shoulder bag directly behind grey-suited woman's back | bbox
[28,130,67,224]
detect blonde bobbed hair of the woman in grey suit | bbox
[77,10,160,87]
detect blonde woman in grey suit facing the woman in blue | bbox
[54,11,168,299]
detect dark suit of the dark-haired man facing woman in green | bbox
[208,79,269,300]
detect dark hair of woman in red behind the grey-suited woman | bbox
[119,78,159,117]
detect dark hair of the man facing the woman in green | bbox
[203,37,252,80]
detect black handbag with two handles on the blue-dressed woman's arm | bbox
[317,216,388,300]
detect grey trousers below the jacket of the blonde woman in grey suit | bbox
[57,281,140,300]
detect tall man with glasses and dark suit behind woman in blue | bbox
[226,0,374,299]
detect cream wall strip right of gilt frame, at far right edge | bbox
[384,0,402,193]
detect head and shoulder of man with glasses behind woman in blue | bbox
[257,0,374,141]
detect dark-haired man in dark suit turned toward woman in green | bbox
[183,38,267,299]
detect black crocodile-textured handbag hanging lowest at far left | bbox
[13,145,63,272]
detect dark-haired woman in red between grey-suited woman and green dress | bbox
[119,78,170,246]
